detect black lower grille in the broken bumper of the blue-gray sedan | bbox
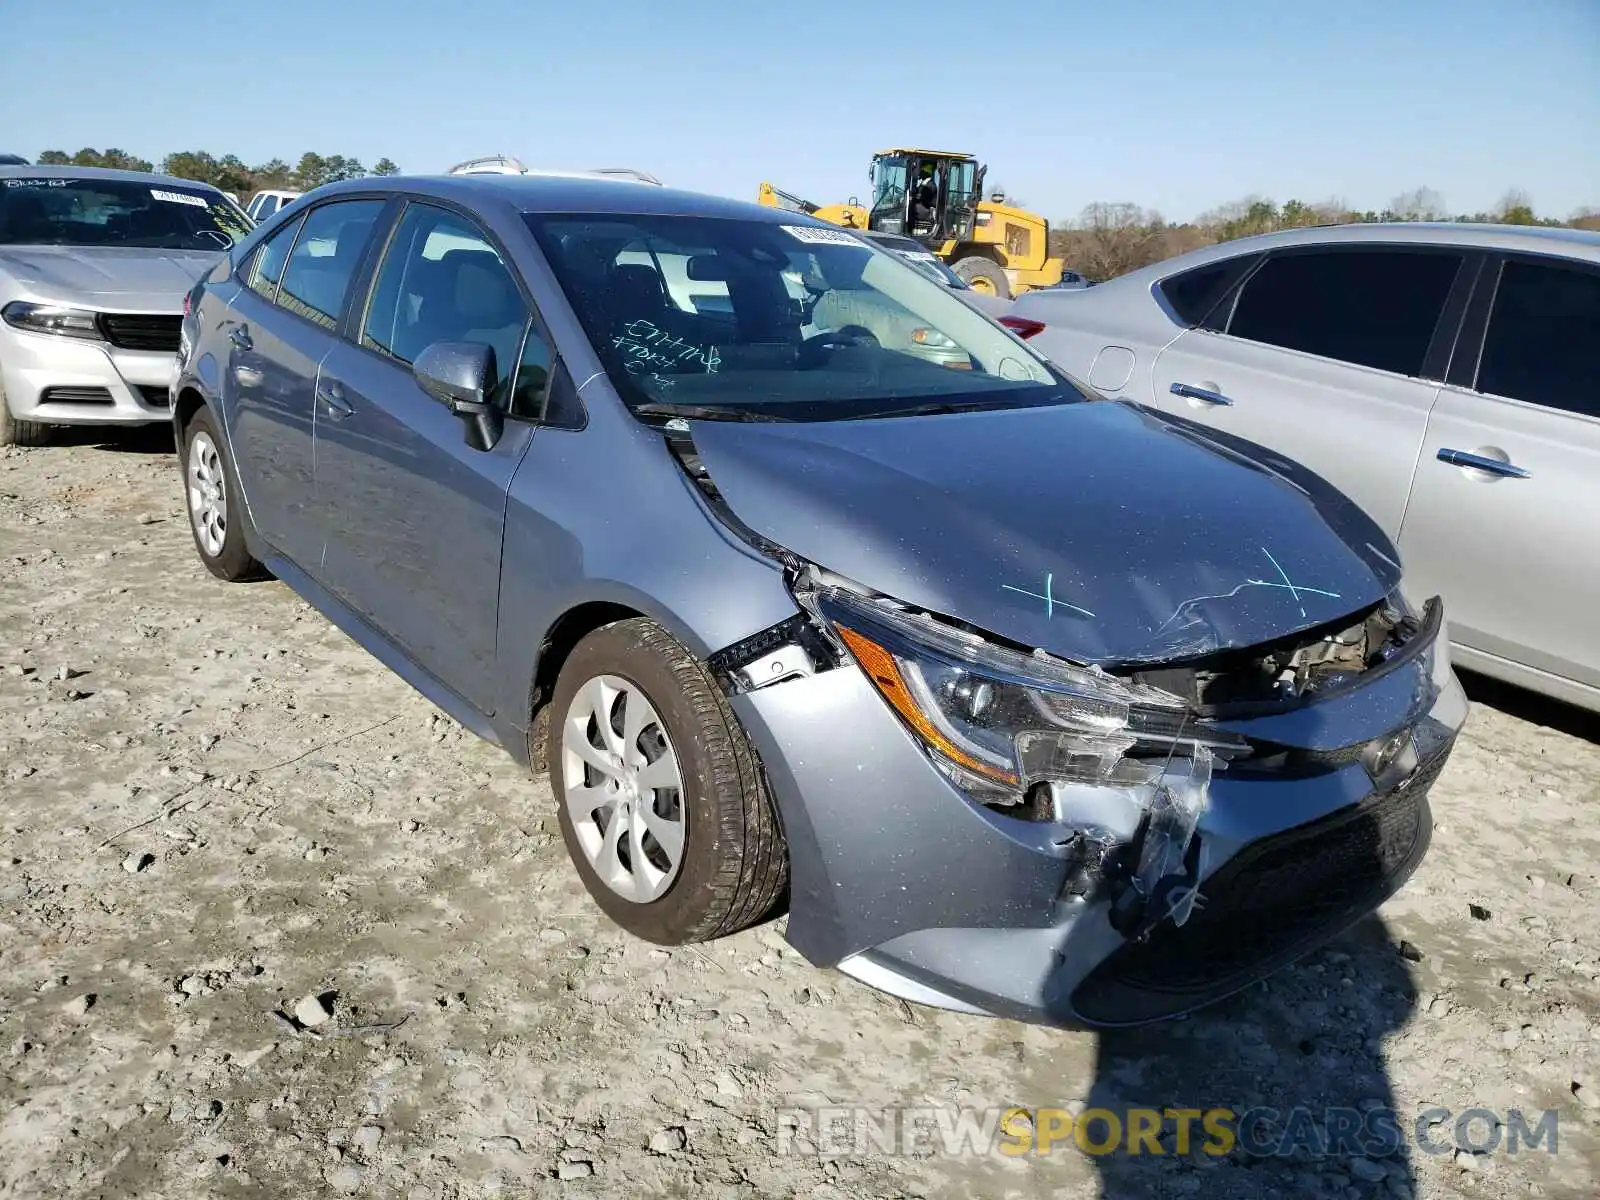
[1072,754,1446,1026]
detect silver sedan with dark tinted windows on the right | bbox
[1013,224,1600,709]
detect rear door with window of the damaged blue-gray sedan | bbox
[227,200,382,574]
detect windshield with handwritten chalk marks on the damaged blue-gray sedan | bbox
[525,214,1085,419]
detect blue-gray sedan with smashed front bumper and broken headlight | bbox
[173,176,1466,1024]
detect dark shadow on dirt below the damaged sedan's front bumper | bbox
[1080,915,1416,1200]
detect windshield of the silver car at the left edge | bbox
[0,174,251,250]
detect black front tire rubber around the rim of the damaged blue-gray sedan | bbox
[549,618,789,946]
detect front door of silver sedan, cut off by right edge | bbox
[1400,256,1600,706]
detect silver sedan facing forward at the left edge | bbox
[0,166,251,446]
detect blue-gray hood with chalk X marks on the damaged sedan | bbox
[693,402,1400,664]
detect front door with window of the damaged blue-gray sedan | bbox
[317,203,550,715]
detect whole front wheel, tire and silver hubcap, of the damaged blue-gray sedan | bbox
[549,618,789,946]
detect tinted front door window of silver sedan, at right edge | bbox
[1478,261,1600,416]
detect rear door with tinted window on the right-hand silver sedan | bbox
[1152,245,1475,536]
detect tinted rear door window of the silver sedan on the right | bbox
[1227,250,1461,374]
